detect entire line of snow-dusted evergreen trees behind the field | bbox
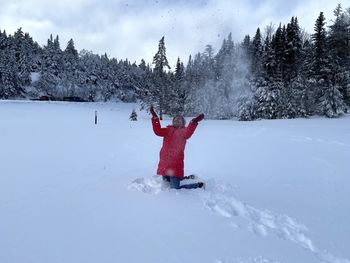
[0,5,350,120]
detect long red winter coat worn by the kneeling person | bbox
[152,118,198,179]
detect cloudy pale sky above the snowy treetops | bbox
[0,0,350,67]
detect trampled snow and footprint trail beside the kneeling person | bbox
[128,176,350,263]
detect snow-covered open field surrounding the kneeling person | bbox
[0,101,350,263]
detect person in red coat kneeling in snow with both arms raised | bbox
[150,107,204,189]
